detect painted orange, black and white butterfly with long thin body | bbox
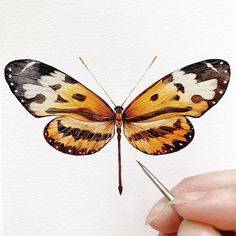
[5,59,230,194]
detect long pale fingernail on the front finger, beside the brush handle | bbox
[168,192,207,205]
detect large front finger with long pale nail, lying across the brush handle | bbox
[174,189,236,230]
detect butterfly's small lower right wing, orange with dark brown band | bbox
[124,116,194,155]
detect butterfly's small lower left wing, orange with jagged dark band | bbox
[44,116,115,155]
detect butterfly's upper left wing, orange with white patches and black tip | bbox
[5,59,114,121]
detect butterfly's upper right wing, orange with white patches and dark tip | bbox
[124,59,230,122]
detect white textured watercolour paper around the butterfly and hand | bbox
[0,0,236,236]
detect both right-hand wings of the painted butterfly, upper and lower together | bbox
[124,59,230,155]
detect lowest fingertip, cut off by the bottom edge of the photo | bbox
[177,220,221,236]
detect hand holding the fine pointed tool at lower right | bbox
[146,170,236,236]
